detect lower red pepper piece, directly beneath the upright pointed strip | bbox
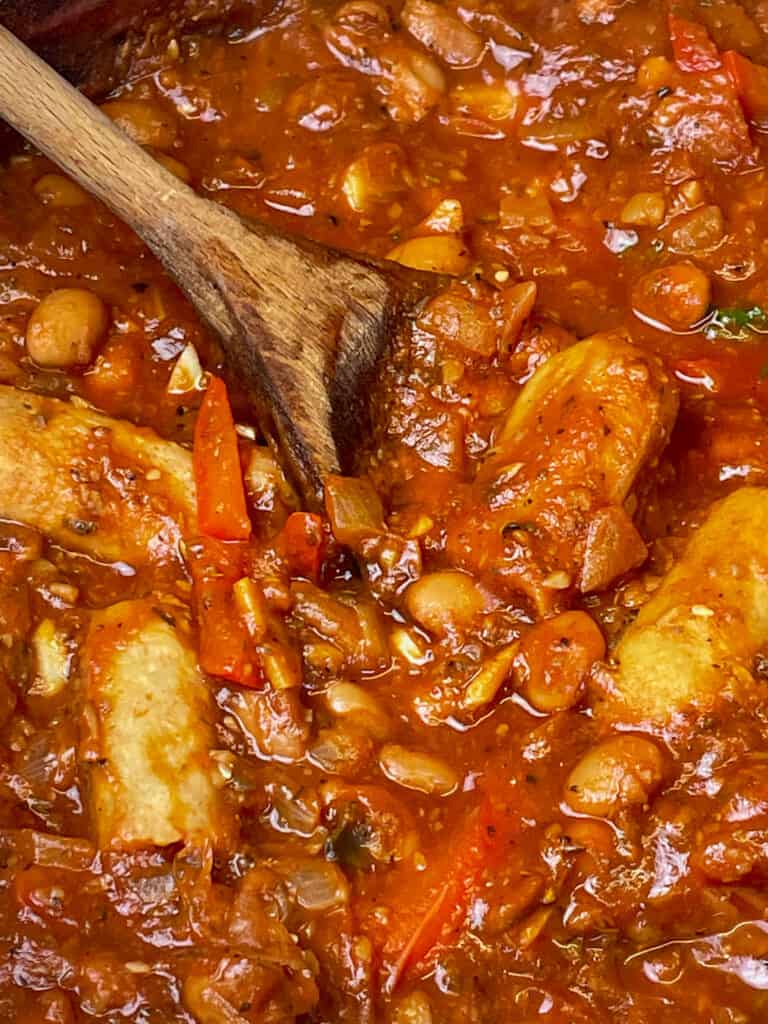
[187,538,263,687]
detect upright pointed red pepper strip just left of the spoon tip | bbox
[193,377,251,541]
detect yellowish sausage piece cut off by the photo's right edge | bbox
[602,487,768,724]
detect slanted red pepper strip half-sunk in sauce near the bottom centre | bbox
[388,797,509,991]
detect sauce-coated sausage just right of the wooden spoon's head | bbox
[449,335,677,609]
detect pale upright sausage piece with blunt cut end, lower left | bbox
[83,600,232,849]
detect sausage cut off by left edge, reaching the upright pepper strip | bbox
[0,387,197,565]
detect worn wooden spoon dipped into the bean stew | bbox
[0,27,438,503]
